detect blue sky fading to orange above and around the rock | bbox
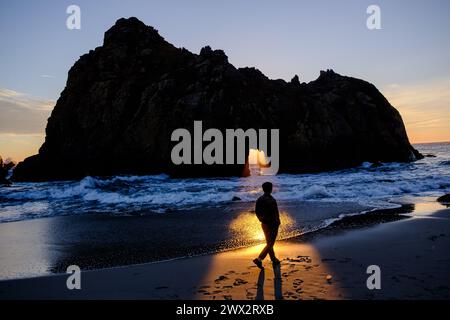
[0,0,450,161]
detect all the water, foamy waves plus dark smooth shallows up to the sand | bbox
[0,143,450,280]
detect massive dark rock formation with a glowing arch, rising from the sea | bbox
[13,18,420,181]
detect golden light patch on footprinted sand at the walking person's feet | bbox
[194,241,342,300]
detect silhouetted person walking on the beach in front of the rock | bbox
[253,182,280,269]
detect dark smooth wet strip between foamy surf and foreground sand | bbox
[0,202,370,280]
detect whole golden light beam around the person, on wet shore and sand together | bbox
[196,204,341,300]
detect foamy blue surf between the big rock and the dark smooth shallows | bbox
[0,143,450,223]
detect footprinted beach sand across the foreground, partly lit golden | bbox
[0,201,450,300]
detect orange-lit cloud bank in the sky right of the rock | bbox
[382,78,450,142]
